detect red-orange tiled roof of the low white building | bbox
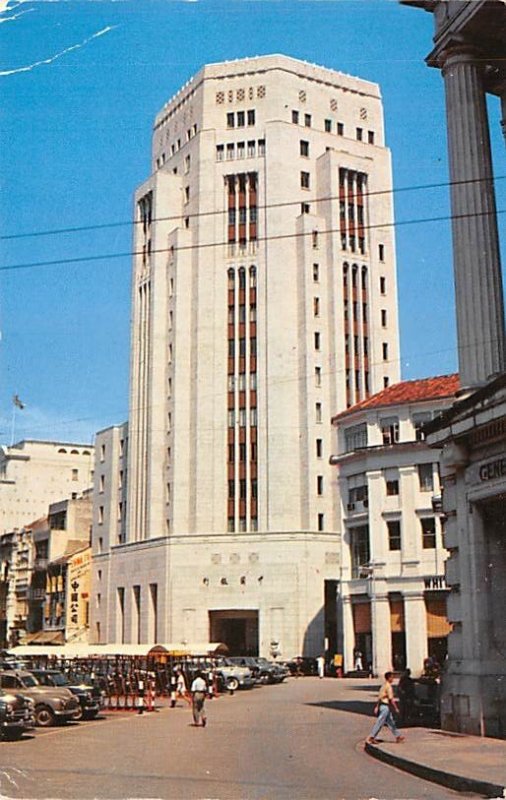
[332,373,460,422]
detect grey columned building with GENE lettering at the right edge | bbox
[404,0,506,737]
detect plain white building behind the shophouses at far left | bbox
[0,439,94,533]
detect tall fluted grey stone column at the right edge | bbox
[443,47,506,388]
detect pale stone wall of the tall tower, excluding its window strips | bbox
[92,56,399,655]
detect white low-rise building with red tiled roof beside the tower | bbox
[331,375,459,675]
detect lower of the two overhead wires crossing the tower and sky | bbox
[0,209,506,272]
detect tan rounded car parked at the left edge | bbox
[0,670,79,728]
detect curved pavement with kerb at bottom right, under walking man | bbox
[365,728,506,798]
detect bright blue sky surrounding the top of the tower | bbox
[0,0,506,443]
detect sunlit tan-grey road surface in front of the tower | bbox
[0,678,476,800]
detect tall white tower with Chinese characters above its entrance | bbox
[92,55,399,655]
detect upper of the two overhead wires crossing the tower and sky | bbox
[0,175,506,241]
